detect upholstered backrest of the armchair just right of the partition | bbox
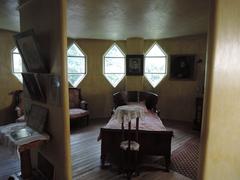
[69,88,82,108]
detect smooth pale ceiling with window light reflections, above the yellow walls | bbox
[0,0,209,40]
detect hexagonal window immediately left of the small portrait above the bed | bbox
[103,43,126,87]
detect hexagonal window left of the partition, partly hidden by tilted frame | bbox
[11,47,23,83]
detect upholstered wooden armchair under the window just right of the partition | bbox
[69,88,89,125]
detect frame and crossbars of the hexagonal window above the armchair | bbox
[67,42,87,87]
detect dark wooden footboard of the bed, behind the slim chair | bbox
[100,128,173,171]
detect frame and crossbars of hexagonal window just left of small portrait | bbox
[103,43,126,88]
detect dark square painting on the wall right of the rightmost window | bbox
[170,55,195,80]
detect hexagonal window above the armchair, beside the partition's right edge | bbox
[67,43,86,87]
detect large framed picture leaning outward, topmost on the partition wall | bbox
[14,30,48,73]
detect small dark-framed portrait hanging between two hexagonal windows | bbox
[126,55,144,76]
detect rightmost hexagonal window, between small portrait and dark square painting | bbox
[144,43,167,88]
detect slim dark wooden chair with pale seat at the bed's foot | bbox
[120,117,140,180]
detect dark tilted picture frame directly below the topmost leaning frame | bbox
[22,73,46,102]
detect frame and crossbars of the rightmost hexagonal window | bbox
[144,42,168,88]
